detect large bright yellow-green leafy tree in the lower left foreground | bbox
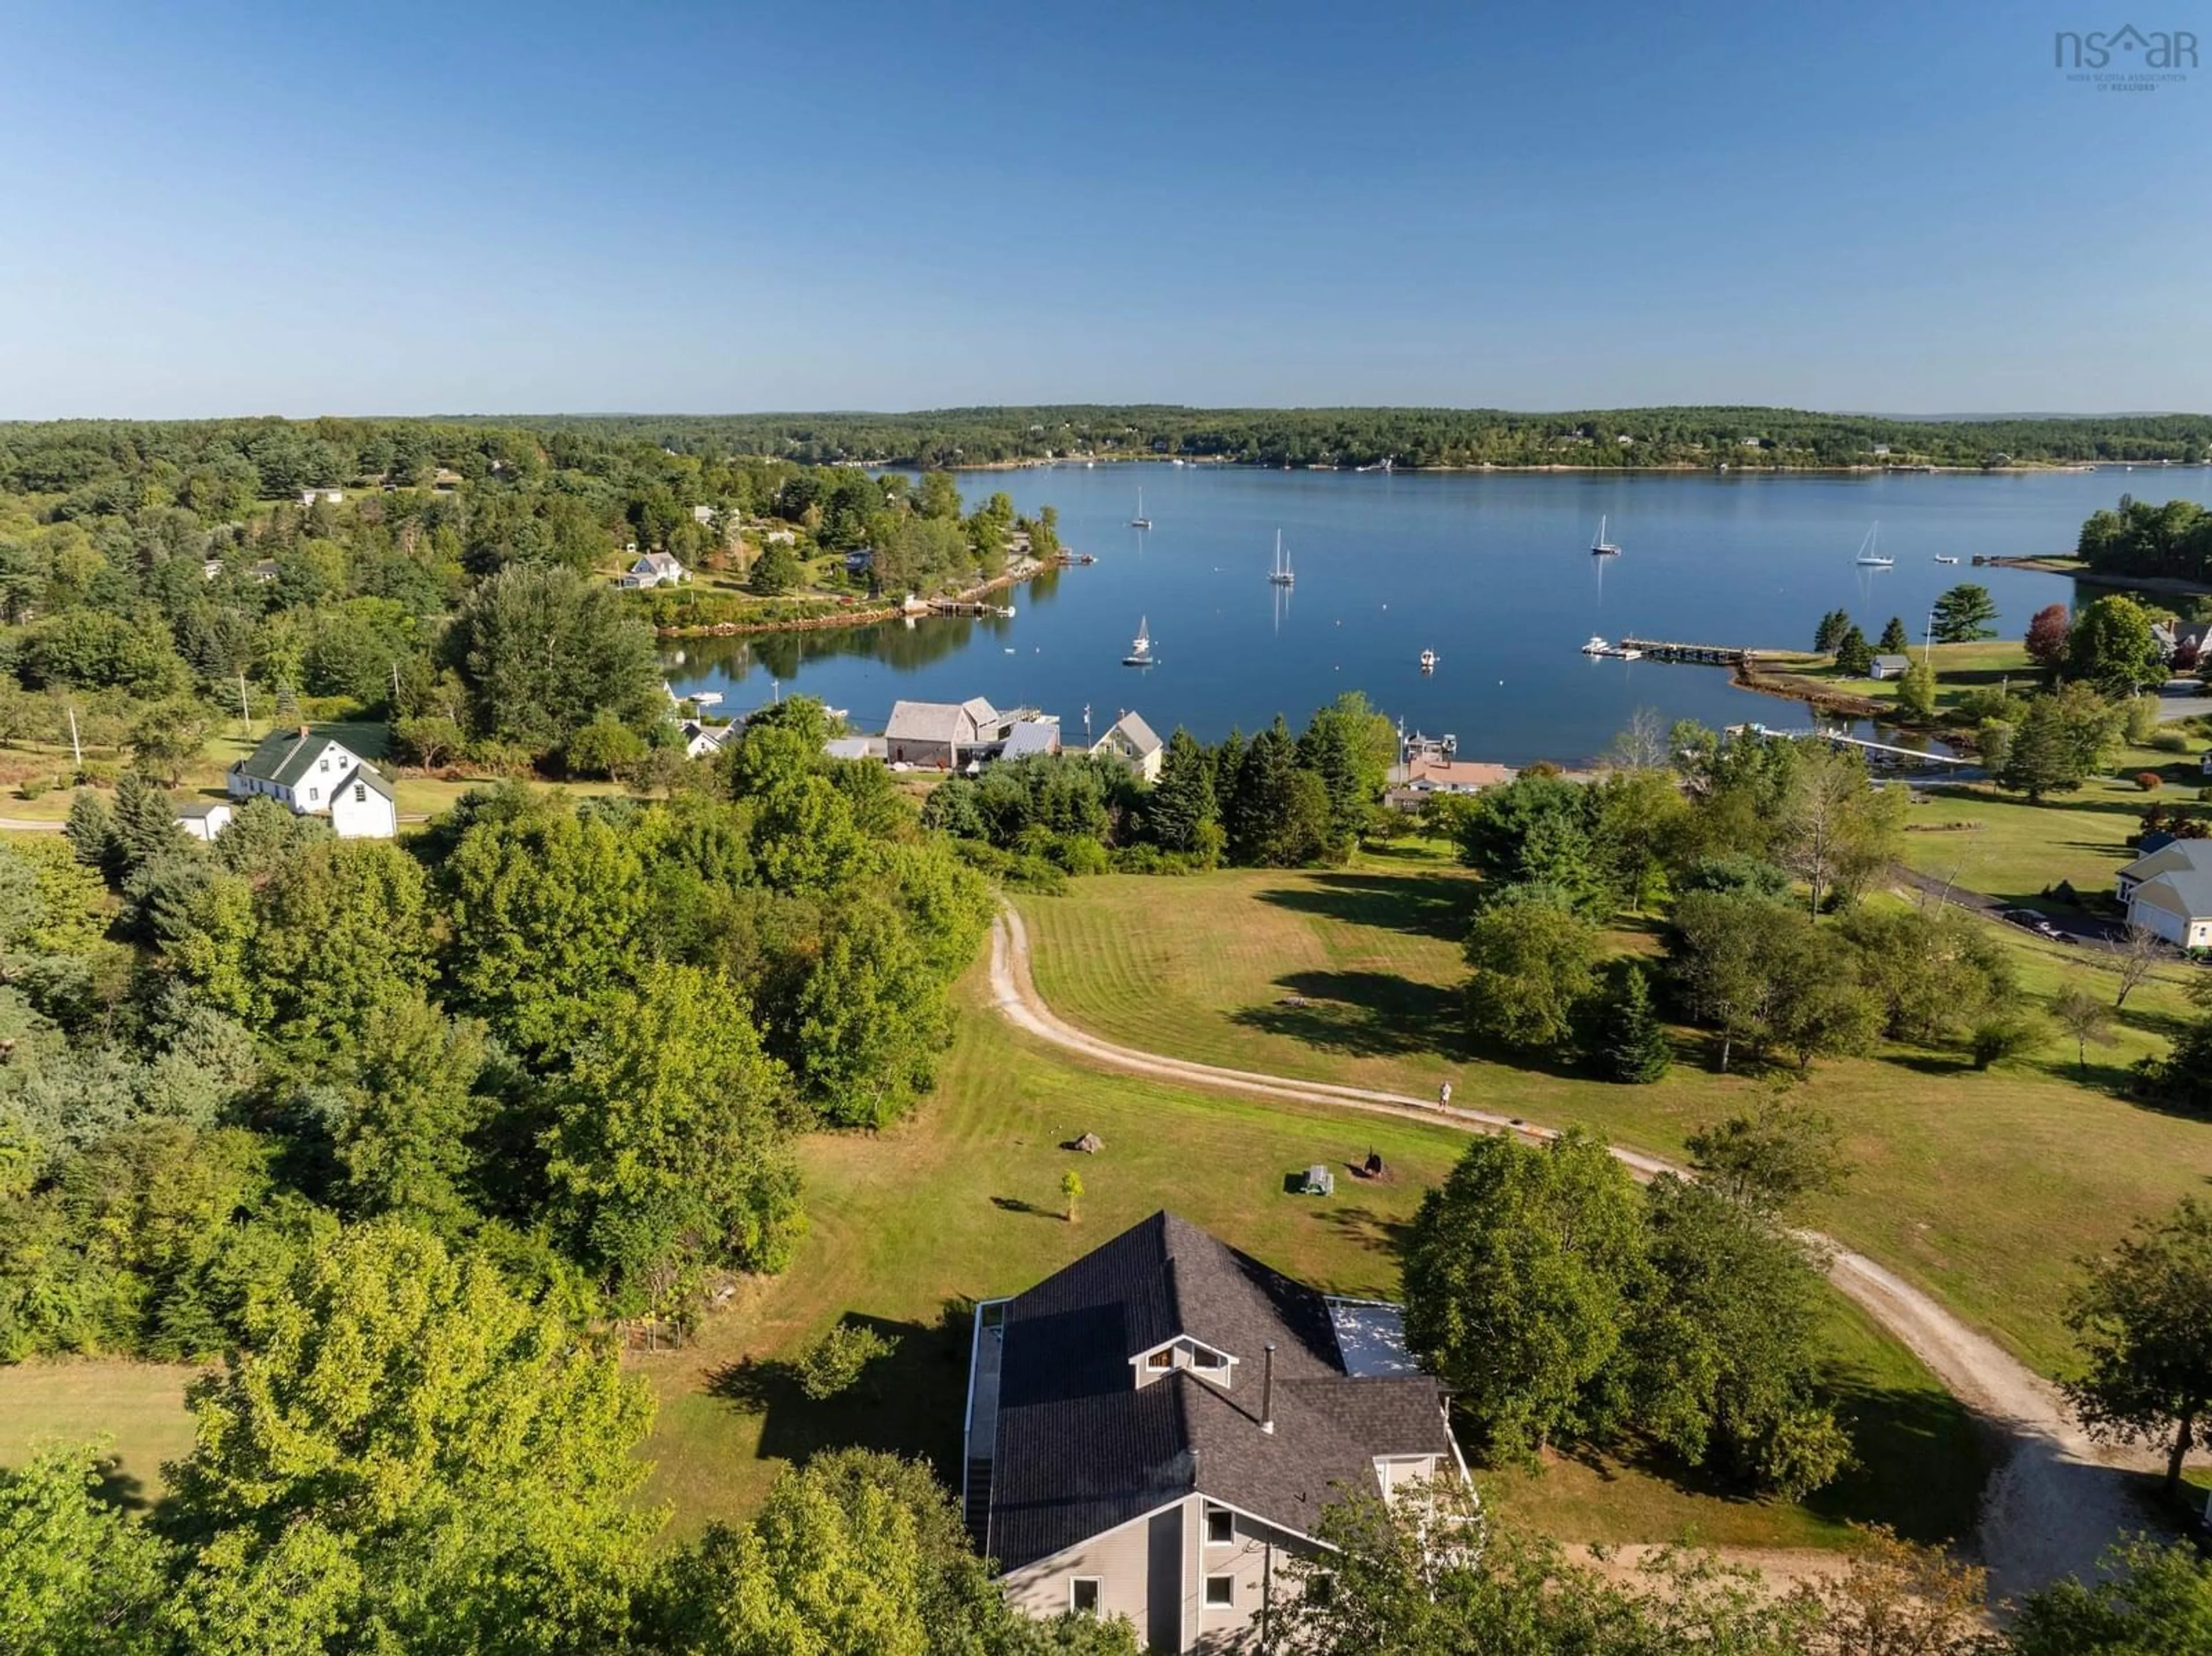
[171,1223,657,1649]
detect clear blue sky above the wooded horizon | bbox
[0,0,2212,418]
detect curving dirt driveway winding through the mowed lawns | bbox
[991,909,2157,1598]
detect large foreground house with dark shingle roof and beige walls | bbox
[964,1214,1464,1651]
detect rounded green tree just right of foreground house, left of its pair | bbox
[1400,1132,1650,1457]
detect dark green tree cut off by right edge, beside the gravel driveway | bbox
[2062,1196,2212,1497]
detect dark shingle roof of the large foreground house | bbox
[984,1214,1453,1570]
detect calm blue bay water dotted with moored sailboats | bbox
[671,464,2212,765]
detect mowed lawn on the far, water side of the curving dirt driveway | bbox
[1022,847,2212,1373]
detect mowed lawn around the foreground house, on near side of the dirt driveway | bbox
[0,973,1984,1545]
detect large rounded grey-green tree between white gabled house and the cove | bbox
[445,564,666,754]
